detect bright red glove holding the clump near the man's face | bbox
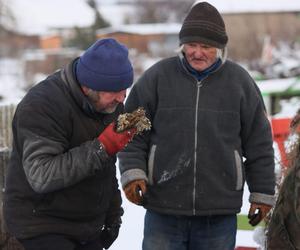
[98,122,136,155]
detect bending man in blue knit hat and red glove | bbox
[4,39,134,250]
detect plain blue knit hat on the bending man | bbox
[76,38,133,92]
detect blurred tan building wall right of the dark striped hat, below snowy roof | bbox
[223,10,300,60]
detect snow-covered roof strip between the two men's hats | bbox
[98,23,182,35]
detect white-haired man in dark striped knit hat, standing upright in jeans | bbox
[118,2,275,250]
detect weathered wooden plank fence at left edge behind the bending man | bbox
[0,105,23,250]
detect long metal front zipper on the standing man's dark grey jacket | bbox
[193,80,202,215]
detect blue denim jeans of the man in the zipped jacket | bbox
[143,210,237,250]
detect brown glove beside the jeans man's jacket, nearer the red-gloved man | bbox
[124,180,146,205]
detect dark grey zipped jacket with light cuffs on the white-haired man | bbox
[118,57,275,215]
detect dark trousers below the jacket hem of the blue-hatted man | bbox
[19,234,103,250]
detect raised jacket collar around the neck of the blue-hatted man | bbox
[61,58,124,124]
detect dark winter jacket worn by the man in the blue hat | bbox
[4,59,123,240]
